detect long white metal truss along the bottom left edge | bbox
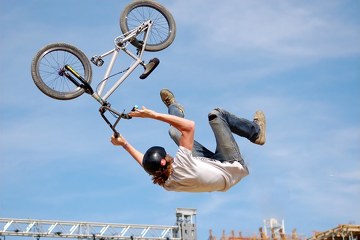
[0,218,181,240]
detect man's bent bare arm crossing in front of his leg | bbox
[129,107,195,150]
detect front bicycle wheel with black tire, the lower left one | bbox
[31,43,92,100]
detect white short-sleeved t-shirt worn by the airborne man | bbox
[164,146,249,192]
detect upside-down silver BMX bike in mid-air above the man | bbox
[31,0,176,136]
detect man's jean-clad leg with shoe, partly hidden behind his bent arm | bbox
[160,89,214,158]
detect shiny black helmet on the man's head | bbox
[142,146,166,175]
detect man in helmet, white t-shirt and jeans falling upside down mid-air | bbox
[111,89,266,192]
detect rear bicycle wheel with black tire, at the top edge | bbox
[120,0,176,52]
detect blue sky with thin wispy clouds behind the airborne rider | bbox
[0,0,360,239]
